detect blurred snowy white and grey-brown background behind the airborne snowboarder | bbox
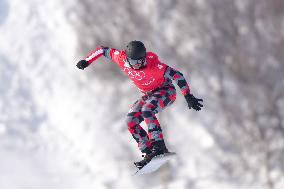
[0,0,284,189]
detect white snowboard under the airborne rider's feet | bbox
[134,152,176,175]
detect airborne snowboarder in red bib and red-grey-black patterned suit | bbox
[77,41,203,169]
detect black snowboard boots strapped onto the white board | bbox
[134,140,169,169]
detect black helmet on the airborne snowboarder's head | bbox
[125,41,146,60]
